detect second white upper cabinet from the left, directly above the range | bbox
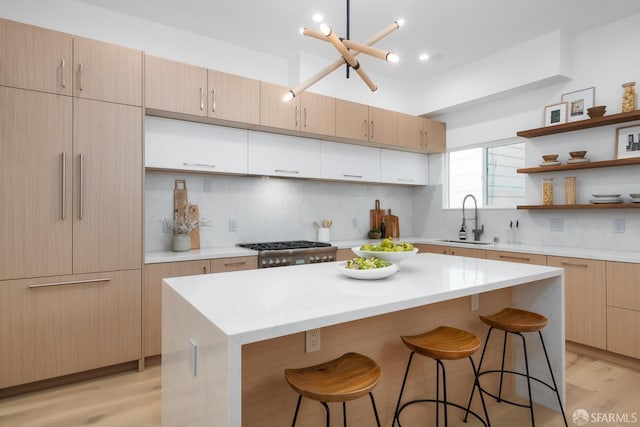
[249,131,320,178]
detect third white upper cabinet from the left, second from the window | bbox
[321,141,380,182]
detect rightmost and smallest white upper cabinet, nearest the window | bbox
[380,149,429,185]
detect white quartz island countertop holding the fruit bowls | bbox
[165,254,563,345]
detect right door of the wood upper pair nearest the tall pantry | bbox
[207,70,260,125]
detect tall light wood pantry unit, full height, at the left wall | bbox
[0,19,143,389]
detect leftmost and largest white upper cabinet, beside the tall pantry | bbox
[145,116,247,174]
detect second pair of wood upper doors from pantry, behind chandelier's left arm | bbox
[260,82,336,136]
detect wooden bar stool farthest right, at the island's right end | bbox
[465,308,568,426]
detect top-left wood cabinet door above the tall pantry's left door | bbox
[0,18,73,95]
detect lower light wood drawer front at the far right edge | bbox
[607,307,640,359]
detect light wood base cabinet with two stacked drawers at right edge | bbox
[607,262,640,358]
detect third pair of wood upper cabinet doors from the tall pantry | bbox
[336,99,398,145]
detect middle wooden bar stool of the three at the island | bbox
[391,326,490,427]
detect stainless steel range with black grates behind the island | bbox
[238,240,338,268]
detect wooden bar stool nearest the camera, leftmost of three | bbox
[284,353,380,427]
